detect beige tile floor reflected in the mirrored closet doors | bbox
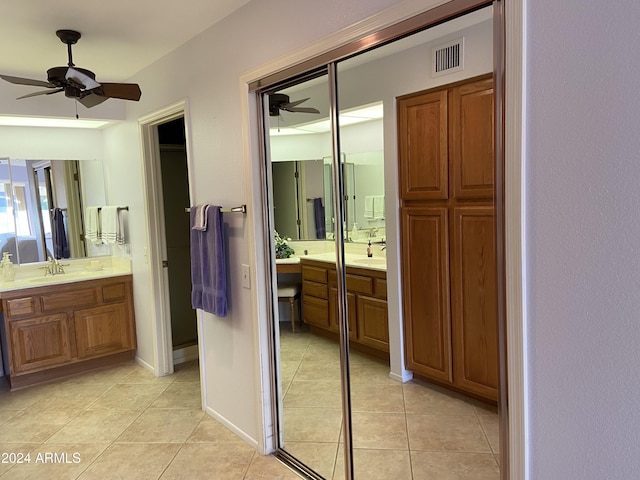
[280,327,500,480]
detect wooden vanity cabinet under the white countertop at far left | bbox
[2,275,136,388]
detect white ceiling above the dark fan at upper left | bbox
[0,0,249,82]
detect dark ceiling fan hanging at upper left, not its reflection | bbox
[0,30,142,108]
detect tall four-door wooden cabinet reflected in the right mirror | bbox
[398,75,498,400]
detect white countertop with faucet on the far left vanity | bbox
[0,257,131,294]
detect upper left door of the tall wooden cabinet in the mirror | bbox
[398,90,449,200]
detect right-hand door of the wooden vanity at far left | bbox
[74,303,133,358]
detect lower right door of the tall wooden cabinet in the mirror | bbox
[451,206,498,400]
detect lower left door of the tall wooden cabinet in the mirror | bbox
[401,207,452,382]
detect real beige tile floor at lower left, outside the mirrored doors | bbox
[0,362,298,480]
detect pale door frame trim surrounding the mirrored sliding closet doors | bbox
[240,0,529,479]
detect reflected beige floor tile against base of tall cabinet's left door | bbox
[403,383,476,415]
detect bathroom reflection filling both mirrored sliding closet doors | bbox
[267,7,500,480]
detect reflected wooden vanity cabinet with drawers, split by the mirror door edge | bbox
[300,259,389,360]
